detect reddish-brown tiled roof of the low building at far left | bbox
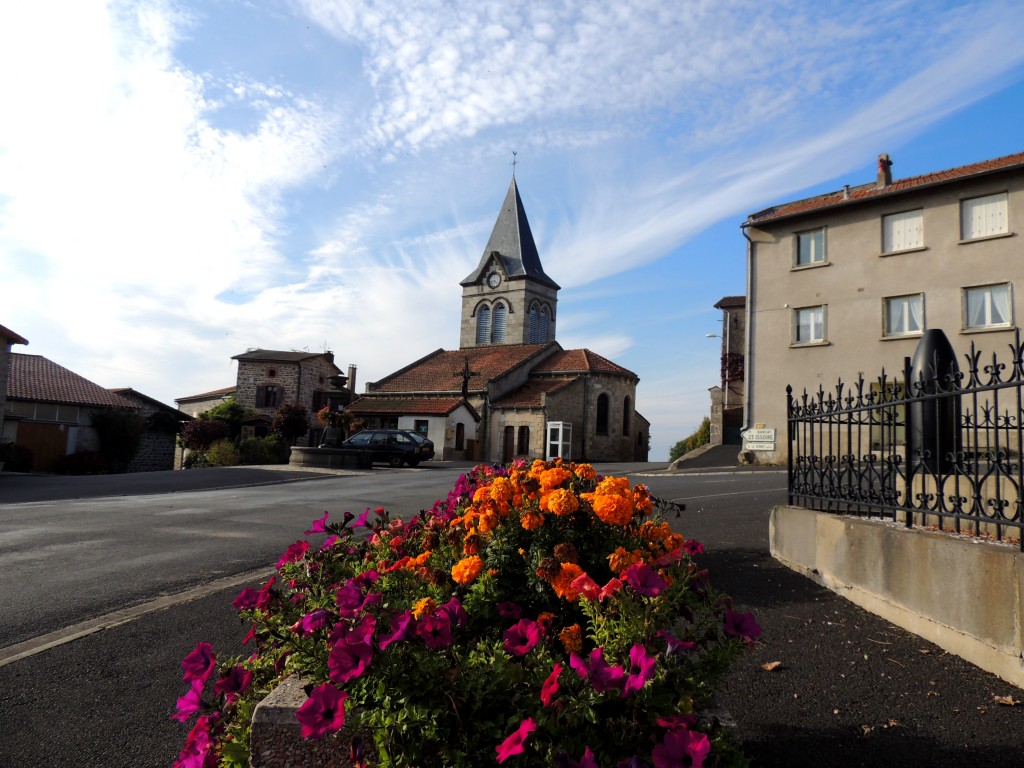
[7,352,137,410]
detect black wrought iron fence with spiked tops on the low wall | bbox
[786,330,1024,551]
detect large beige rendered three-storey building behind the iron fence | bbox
[742,153,1024,463]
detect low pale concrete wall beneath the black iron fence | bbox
[769,507,1024,688]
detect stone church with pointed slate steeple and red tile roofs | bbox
[347,175,650,463]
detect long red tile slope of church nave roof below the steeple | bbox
[368,344,560,393]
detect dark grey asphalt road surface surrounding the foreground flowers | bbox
[0,466,1024,768]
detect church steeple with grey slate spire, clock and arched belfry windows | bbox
[460,176,559,348]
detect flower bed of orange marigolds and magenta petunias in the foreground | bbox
[173,461,760,768]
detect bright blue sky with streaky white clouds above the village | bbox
[0,0,1024,460]
